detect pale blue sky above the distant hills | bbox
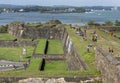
[0,0,120,6]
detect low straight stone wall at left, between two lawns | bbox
[0,40,38,47]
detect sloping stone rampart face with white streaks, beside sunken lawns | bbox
[62,29,89,70]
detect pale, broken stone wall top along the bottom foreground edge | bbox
[0,76,101,83]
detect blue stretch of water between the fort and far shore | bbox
[0,11,120,25]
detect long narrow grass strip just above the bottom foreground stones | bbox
[0,69,100,77]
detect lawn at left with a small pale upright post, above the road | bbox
[0,47,34,61]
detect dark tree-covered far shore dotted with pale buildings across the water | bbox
[0,6,85,13]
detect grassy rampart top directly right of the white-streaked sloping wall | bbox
[66,26,99,75]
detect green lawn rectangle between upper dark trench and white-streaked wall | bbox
[47,40,64,54]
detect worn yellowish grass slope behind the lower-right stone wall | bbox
[97,30,120,57]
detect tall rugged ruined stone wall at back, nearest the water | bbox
[8,23,64,39]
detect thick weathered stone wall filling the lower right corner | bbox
[96,47,120,83]
